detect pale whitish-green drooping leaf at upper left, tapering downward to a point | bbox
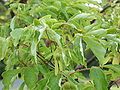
[10,28,23,46]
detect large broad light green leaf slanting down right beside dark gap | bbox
[84,37,106,64]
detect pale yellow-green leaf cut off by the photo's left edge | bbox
[0,37,9,60]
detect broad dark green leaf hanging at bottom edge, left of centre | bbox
[24,67,38,89]
